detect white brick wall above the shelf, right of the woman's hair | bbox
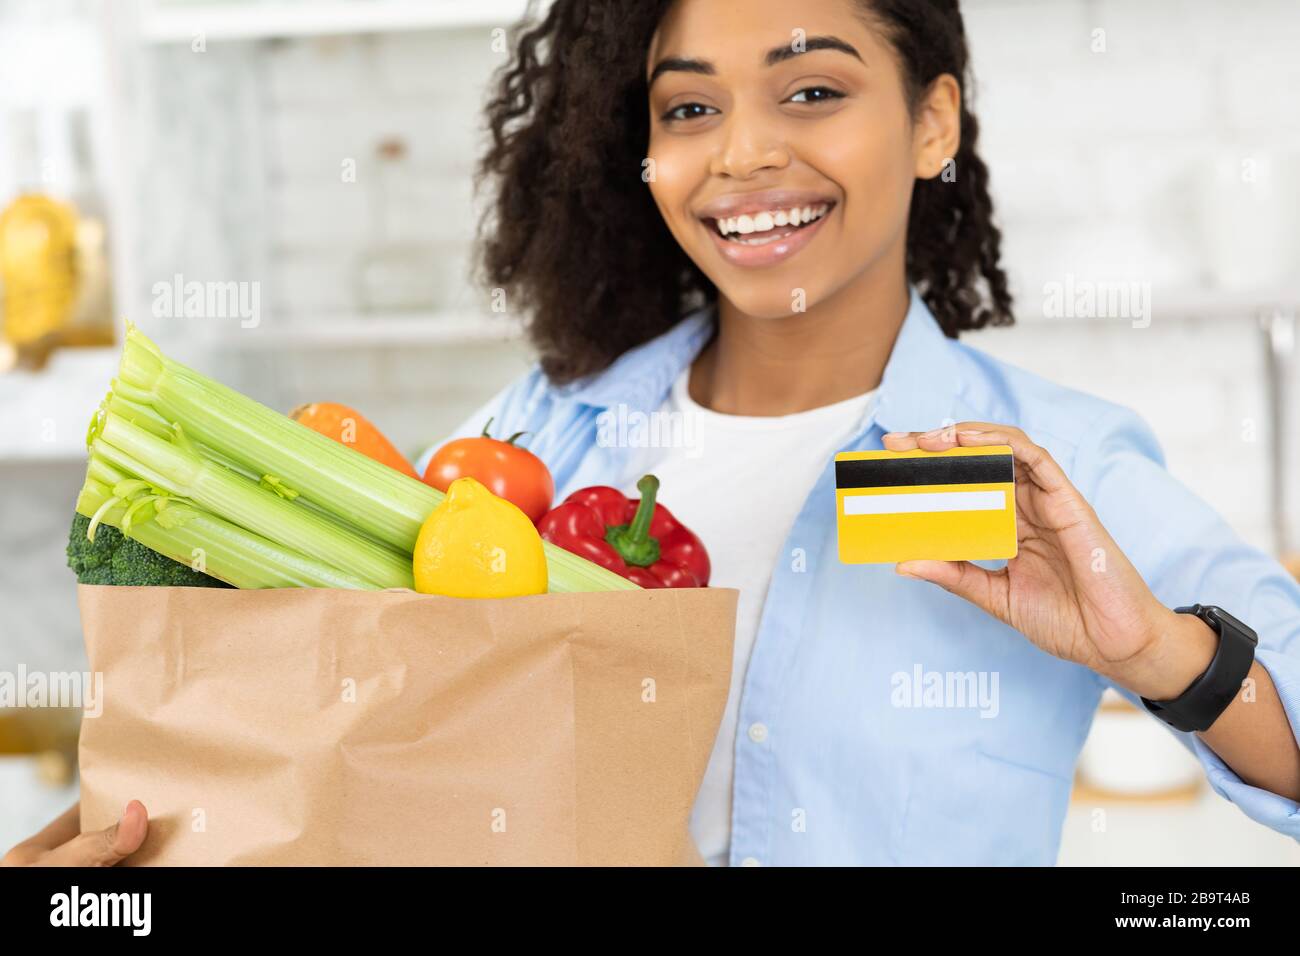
[966,0,1300,299]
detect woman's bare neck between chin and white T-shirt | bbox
[689,260,909,416]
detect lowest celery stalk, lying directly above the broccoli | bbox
[77,478,374,591]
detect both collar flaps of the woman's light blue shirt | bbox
[555,286,962,432]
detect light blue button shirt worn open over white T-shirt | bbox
[419,290,1300,865]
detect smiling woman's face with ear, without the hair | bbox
[646,0,943,317]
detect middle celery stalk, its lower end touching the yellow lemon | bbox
[91,411,413,588]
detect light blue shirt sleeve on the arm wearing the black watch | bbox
[1074,408,1300,840]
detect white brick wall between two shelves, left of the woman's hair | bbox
[267,30,502,315]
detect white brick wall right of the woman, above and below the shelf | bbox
[963,0,1300,546]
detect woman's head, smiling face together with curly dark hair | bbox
[481,0,1011,390]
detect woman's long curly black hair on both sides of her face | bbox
[477,0,1013,384]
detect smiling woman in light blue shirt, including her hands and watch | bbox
[10,0,1300,865]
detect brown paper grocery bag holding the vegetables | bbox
[78,585,737,865]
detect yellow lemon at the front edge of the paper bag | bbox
[413,477,546,597]
